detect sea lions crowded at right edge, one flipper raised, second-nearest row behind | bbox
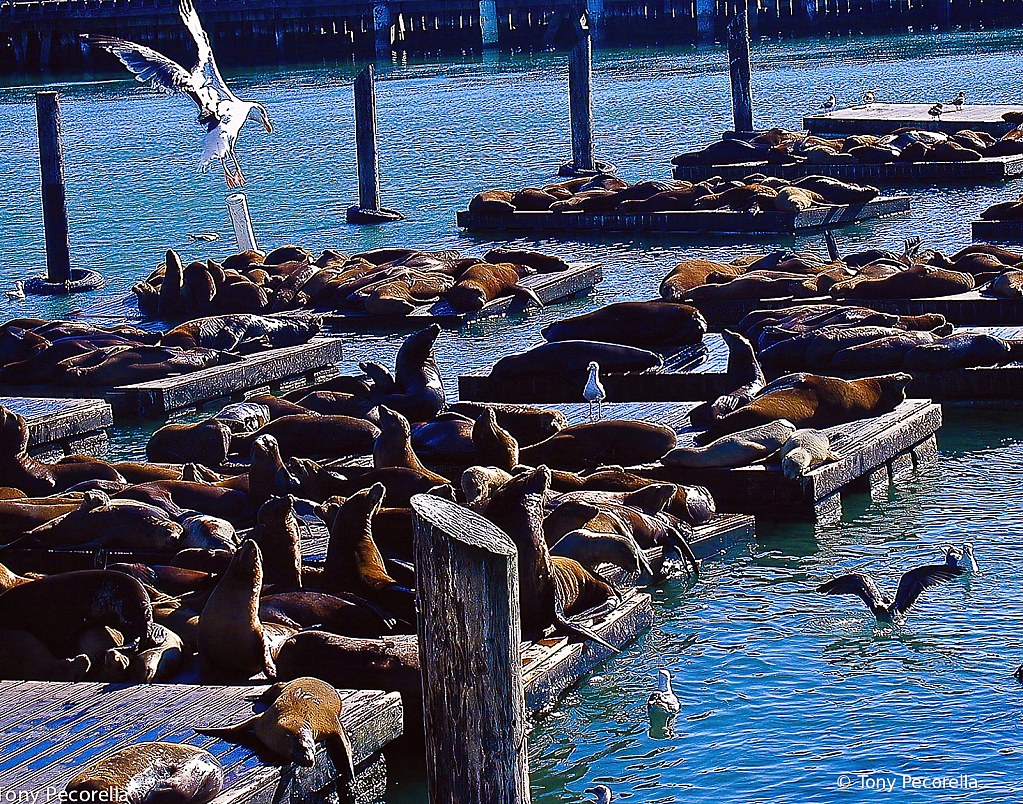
[660,238,1023,306]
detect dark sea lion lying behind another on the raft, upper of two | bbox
[540,302,707,350]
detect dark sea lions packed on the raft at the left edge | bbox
[0,314,320,387]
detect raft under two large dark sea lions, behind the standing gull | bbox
[458,332,727,404]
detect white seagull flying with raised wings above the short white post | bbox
[82,0,273,187]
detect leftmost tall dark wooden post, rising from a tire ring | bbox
[36,92,71,282]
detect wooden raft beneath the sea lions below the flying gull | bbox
[320,263,604,332]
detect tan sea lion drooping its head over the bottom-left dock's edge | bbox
[195,677,355,780]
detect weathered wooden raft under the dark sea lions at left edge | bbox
[0,338,342,418]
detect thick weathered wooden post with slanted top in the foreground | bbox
[411,494,530,804]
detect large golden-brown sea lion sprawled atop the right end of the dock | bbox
[697,372,913,437]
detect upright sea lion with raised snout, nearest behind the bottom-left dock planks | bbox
[197,540,291,680]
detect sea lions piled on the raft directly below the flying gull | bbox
[132,245,569,319]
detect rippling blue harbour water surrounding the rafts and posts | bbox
[0,25,1023,804]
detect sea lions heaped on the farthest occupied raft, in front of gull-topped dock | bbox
[671,128,1023,167]
